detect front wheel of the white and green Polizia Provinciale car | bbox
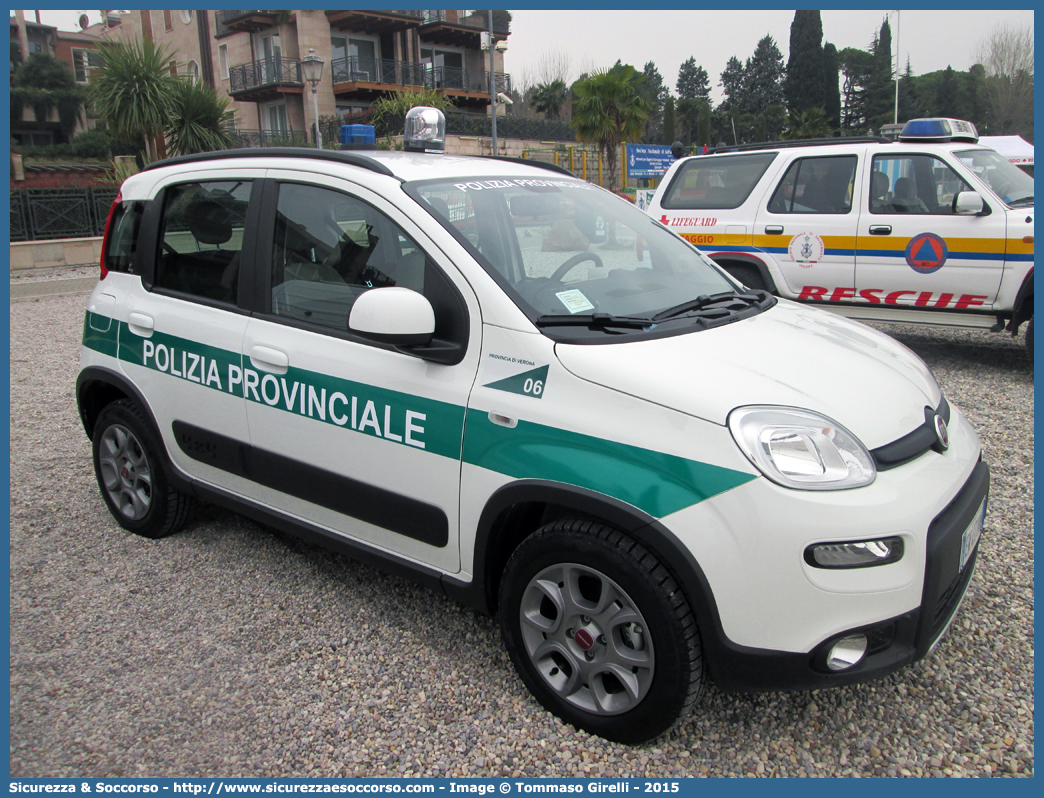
[499,519,704,744]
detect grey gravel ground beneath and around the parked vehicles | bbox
[10,296,1034,778]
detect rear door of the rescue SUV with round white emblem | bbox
[755,151,860,302]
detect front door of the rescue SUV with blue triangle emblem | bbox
[856,152,1005,310]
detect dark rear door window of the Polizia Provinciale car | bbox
[156,181,252,305]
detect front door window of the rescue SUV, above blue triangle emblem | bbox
[870,155,971,216]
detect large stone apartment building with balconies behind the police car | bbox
[119,10,511,143]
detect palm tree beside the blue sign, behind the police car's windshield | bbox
[570,65,653,186]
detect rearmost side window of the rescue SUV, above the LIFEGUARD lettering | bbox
[660,152,778,210]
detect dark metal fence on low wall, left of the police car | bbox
[10,186,119,241]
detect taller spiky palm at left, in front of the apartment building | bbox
[89,39,179,161]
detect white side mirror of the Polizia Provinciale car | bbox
[348,287,435,347]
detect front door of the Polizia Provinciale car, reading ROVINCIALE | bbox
[242,170,480,572]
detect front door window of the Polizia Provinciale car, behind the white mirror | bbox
[271,183,462,342]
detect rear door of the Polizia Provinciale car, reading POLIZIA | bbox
[119,170,263,494]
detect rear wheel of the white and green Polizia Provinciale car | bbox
[92,399,193,538]
